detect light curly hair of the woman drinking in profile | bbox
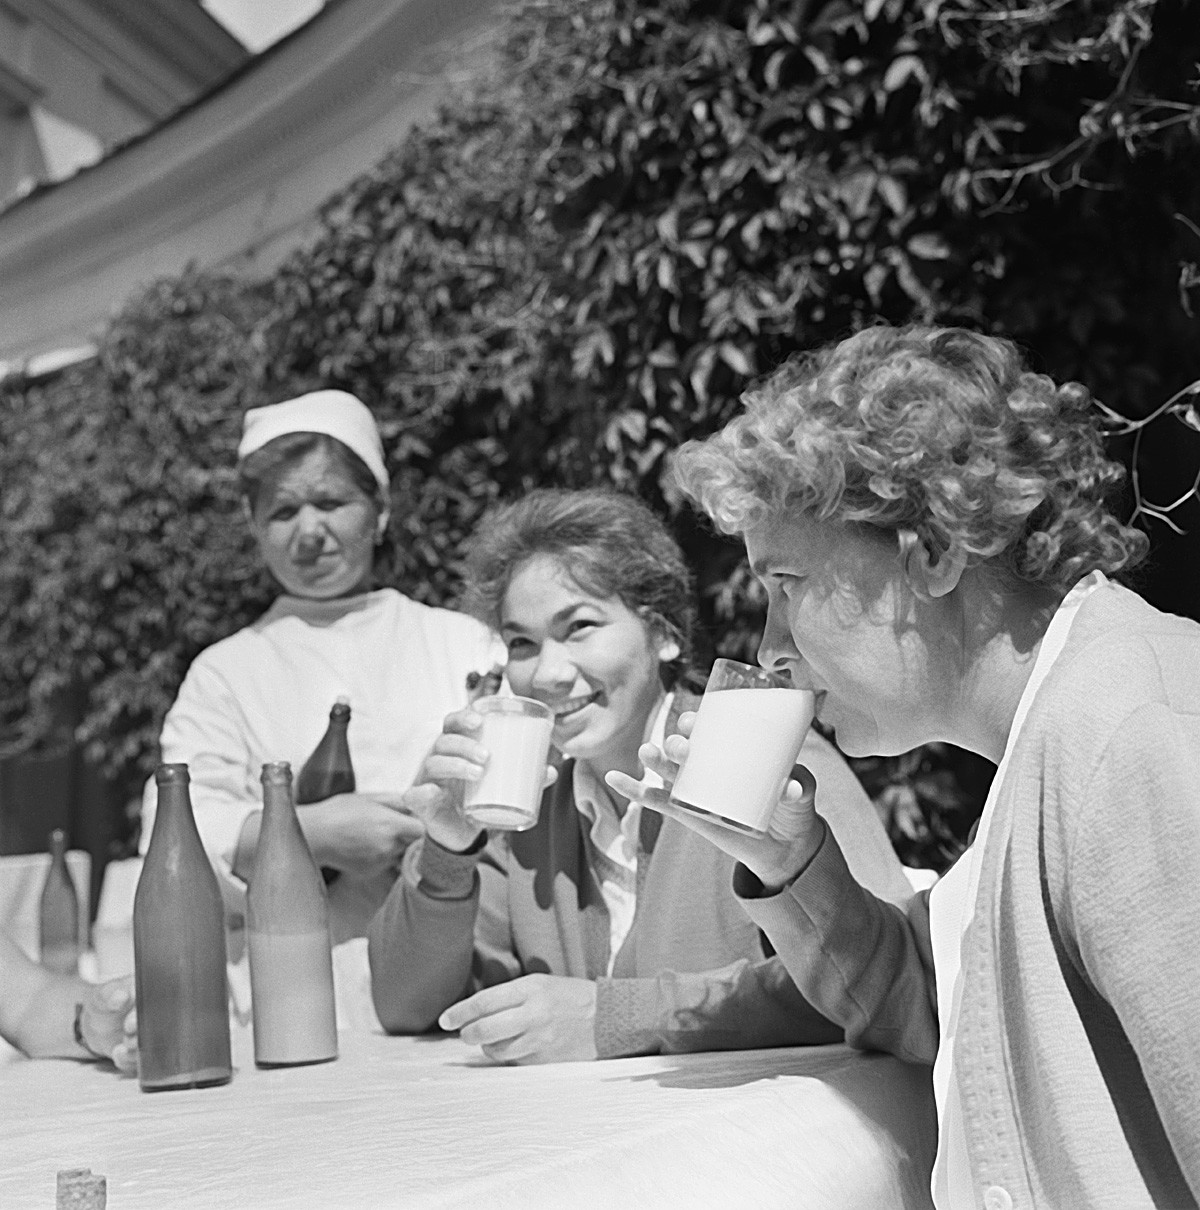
[674,327,1149,592]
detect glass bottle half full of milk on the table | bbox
[246,761,338,1067]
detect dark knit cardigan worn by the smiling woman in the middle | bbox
[369,702,907,1058]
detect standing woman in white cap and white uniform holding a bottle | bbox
[142,391,502,943]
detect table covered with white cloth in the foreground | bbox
[0,1029,935,1210]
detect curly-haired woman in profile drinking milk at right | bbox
[610,328,1200,1210]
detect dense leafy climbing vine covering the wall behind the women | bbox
[0,0,1200,866]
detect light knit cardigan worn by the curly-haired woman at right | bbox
[734,584,1200,1210]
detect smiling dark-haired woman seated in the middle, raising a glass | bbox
[370,490,910,1062]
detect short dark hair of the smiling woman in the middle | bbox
[463,488,696,687]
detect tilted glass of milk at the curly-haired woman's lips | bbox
[671,659,817,836]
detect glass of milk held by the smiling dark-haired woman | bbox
[462,697,554,831]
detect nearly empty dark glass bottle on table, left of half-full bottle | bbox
[133,765,233,1093]
